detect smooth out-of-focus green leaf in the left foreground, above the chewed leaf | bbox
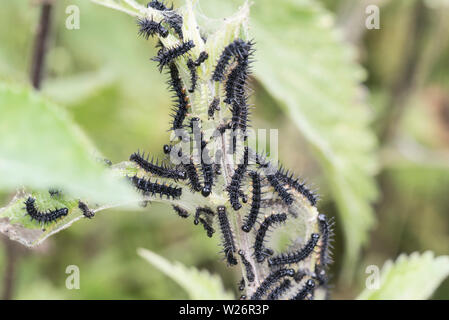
[0,83,138,203]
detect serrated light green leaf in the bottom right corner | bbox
[357,251,449,300]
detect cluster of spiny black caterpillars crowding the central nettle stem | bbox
[130,0,332,300]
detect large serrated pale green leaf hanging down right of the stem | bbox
[229,0,377,279]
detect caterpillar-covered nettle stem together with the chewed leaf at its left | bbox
[2,0,332,300]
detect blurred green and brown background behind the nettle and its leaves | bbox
[0,0,449,299]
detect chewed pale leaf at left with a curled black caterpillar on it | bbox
[0,161,203,247]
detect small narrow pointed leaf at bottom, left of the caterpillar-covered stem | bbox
[137,248,234,300]
